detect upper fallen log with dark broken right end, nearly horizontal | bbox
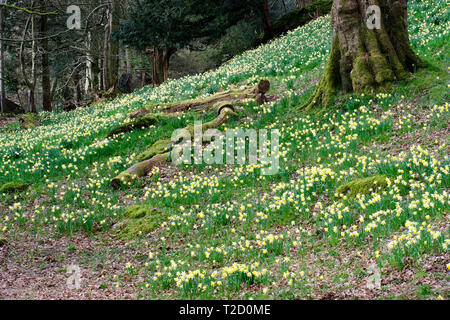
[129,80,270,119]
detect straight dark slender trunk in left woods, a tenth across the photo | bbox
[40,0,52,112]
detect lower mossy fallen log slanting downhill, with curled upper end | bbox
[111,102,237,188]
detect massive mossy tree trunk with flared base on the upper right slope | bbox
[303,0,425,109]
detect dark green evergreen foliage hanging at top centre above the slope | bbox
[113,0,259,50]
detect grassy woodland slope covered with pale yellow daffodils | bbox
[0,0,449,298]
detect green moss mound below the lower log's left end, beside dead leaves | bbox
[117,205,164,240]
